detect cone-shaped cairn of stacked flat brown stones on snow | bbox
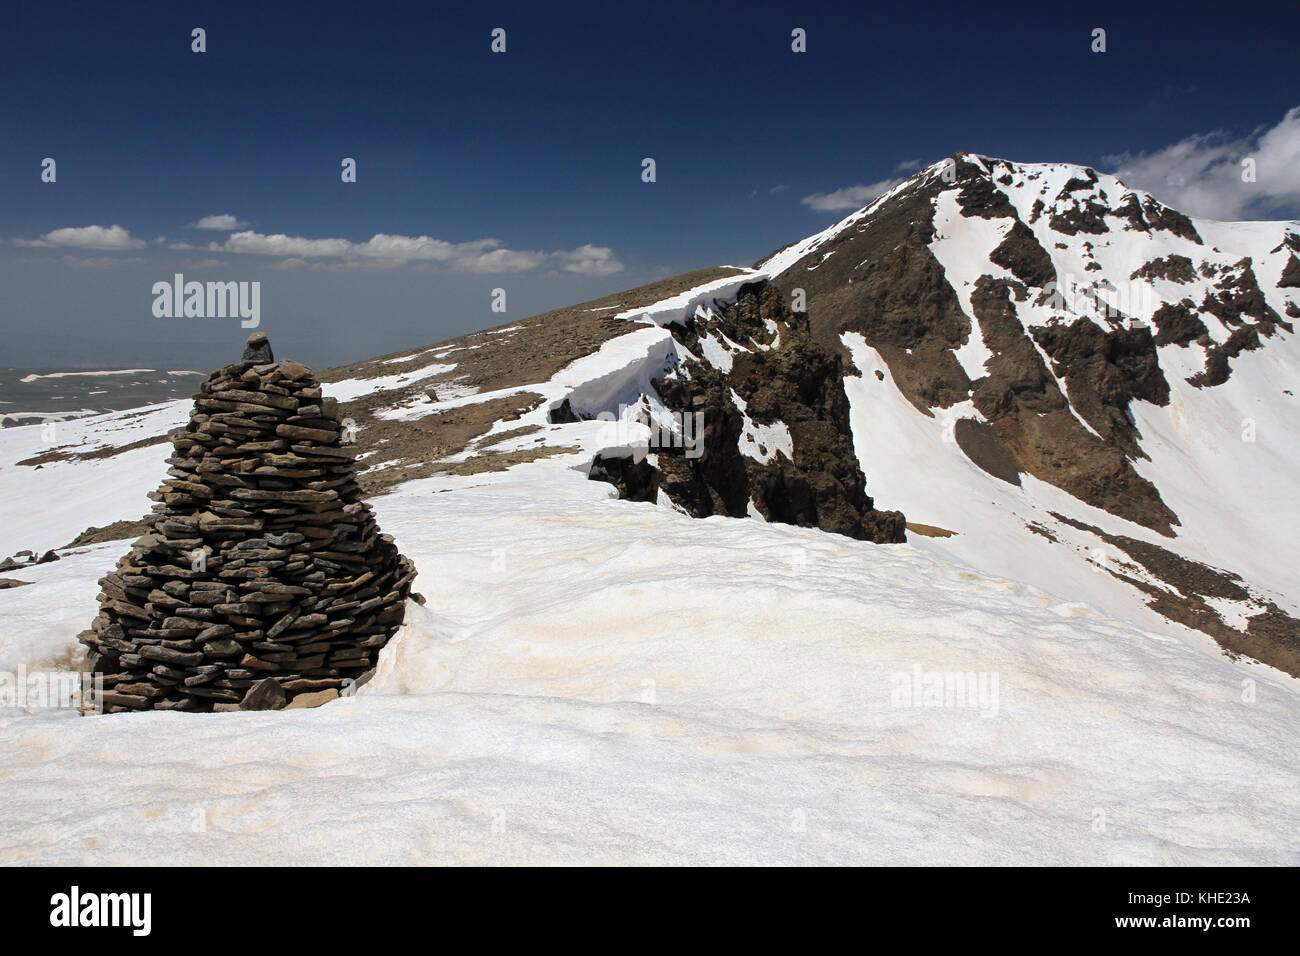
[81,333,420,713]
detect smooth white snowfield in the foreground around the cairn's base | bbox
[0,455,1300,865]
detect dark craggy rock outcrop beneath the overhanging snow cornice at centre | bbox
[590,284,906,542]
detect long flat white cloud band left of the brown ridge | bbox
[208,230,623,276]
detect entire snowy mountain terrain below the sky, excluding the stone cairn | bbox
[0,153,1300,864]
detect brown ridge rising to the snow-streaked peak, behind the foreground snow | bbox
[0,153,1300,674]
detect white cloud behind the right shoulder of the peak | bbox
[1102,107,1300,220]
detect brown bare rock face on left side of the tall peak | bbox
[774,155,1179,535]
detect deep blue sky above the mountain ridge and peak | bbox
[0,3,1300,368]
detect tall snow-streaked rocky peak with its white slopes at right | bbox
[762,155,1300,675]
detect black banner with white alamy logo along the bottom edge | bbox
[3,868,1294,947]
